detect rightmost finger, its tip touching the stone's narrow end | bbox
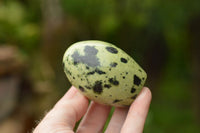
[121,87,152,133]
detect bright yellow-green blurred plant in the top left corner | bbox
[0,1,40,52]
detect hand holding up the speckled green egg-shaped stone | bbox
[33,87,151,133]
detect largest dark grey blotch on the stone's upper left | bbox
[72,46,100,67]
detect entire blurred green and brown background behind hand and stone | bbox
[0,0,200,133]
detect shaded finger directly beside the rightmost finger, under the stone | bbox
[105,108,128,133]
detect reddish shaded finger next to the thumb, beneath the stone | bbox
[77,102,110,133]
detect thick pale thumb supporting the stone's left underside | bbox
[34,87,88,133]
